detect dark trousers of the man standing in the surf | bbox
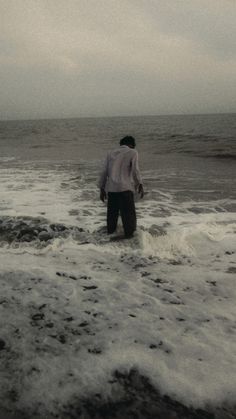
[107,191,136,237]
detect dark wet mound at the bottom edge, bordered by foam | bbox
[59,370,222,419]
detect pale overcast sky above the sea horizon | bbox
[0,0,236,119]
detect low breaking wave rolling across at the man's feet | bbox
[0,217,236,263]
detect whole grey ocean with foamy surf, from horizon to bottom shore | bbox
[0,114,236,419]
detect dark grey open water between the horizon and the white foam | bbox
[0,114,236,206]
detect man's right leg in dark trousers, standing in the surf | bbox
[120,191,137,237]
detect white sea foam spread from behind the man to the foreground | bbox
[0,162,236,412]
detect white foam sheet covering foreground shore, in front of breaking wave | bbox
[0,233,236,411]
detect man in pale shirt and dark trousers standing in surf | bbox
[98,136,144,238]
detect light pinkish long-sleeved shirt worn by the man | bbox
[98,145,142,192]
